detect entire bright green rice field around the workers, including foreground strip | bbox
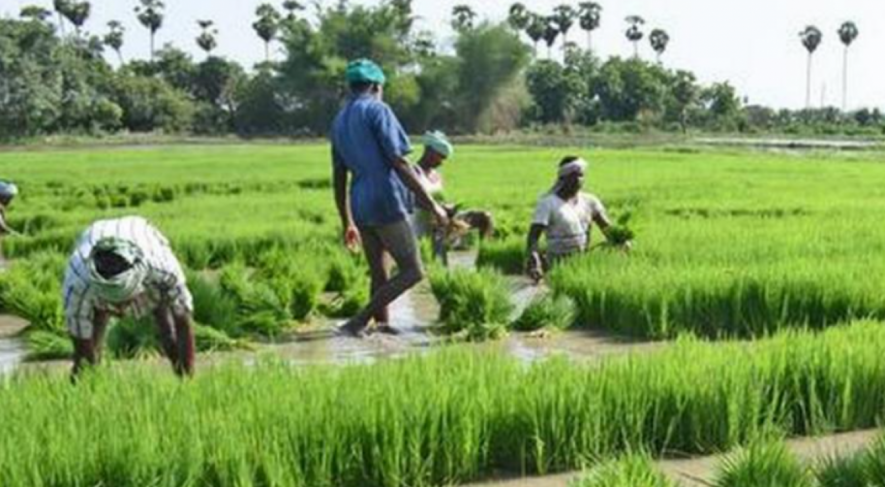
[0,144,885,487]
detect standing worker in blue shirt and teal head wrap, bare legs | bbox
[331,59,448,336]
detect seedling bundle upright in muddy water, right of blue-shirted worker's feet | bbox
[430,269,513,341]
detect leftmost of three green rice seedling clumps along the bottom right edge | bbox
[569,454,676,487]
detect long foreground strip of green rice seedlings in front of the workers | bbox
[0,322,885,487]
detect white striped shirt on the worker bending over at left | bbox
[62,216,193,339]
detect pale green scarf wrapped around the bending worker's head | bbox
[89,237,148,304]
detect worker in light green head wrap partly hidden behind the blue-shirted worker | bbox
[409,131,494,265]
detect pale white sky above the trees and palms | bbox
[0,0,885,108]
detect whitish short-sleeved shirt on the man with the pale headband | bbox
[532,193,607,256]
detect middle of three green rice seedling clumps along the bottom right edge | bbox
[715,439,814,487]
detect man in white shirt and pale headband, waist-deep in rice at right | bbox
[526,156,630,281]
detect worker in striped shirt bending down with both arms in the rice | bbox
[62,217,194,377]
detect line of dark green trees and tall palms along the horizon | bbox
[0,0,883,139]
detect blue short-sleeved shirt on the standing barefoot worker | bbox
[331,95,412,226]
